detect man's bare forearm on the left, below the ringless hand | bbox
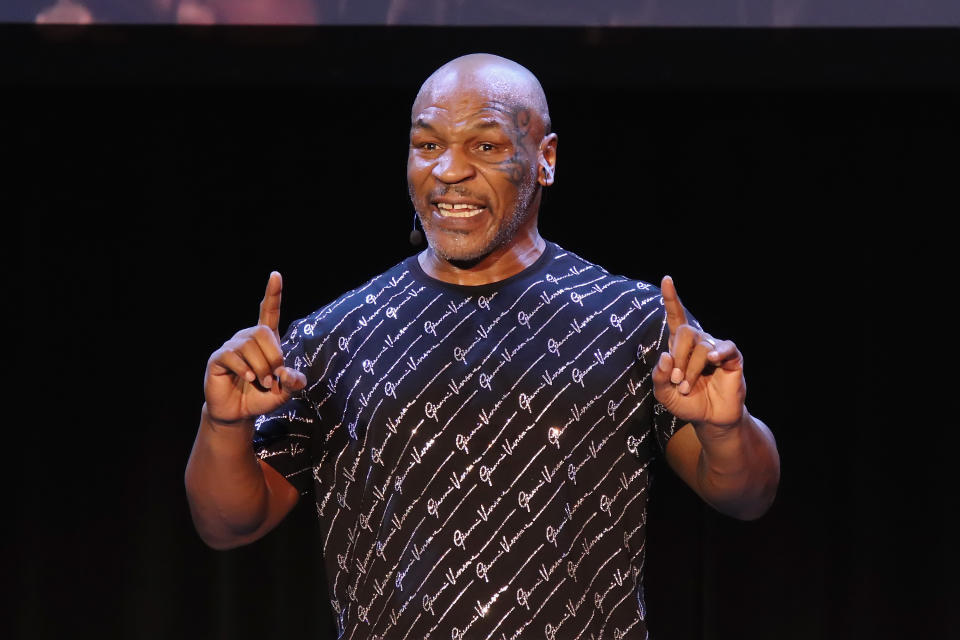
[184,405,269,548]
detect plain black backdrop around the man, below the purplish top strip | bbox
[0,26,960,640]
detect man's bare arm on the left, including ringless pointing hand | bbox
[184,272,306,549]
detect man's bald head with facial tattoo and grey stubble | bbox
[407,54,557,264]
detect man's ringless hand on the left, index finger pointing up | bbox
[203,271,307,425]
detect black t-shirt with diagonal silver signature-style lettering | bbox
[255,242,680,640]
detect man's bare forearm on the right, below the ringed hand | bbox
[694,410,780,520]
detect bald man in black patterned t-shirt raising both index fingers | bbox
[186,54,779,640]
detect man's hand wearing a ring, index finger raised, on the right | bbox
[653,276,747,427]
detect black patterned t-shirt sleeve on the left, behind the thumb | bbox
[253,323,320,495]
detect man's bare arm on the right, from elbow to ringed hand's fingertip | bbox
[653,276,780,520]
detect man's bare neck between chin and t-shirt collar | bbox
[417,225,547,286]
